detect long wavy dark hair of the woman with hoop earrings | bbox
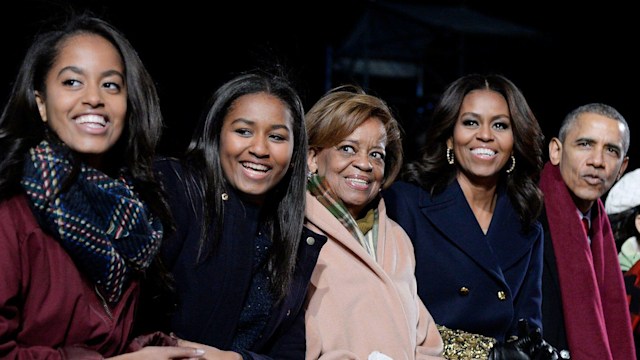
[401,74,544,229]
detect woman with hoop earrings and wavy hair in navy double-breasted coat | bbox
[383,74,543,342]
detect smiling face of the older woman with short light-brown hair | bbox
[308,118,387,219]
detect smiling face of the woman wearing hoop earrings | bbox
[447,90,513,184]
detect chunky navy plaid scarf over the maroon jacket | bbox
[21,140,162,304]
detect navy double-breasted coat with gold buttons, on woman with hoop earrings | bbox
[383,181,543,341]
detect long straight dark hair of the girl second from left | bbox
[179,70,307,299]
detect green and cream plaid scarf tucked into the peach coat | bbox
[307,174,378,260]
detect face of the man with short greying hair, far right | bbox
[549,113,629,213]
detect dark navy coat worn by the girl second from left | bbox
[156,160,326,360]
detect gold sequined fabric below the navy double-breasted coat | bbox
[437,325,497,360]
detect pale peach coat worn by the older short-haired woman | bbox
[305,192,443,360]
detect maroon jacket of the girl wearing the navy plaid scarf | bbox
[0,195,139,359]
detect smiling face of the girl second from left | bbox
[220,93,294,204]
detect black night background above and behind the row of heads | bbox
[0,0,640,173]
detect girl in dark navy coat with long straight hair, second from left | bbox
[146,71,326,359]
